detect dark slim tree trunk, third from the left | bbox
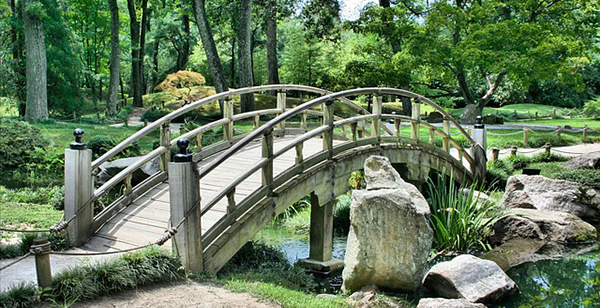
[127,0,143,107]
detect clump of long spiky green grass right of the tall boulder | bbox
[426,174,506,252]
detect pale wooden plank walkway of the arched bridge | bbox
[83,136,323,251]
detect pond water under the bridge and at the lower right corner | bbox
[255,228,600,308]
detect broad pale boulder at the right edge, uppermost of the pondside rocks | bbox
[501,175,600,219]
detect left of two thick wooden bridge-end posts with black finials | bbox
[65,128,94,246]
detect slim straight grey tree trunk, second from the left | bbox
[106,0,121,117]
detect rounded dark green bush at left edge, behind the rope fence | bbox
[0,118,50,169]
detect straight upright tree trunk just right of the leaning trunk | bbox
[238,0,254,112]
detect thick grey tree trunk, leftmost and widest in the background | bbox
[23,0,48,122]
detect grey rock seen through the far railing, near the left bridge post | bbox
[96,157,160,184]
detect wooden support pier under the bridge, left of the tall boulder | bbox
[300,192,344,273]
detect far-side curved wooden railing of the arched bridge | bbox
[74,85,376,243]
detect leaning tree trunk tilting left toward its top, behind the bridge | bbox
[194,0,229,95]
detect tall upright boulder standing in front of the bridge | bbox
[342,156,433,291]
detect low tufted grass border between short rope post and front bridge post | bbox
[52,247,183,302]
